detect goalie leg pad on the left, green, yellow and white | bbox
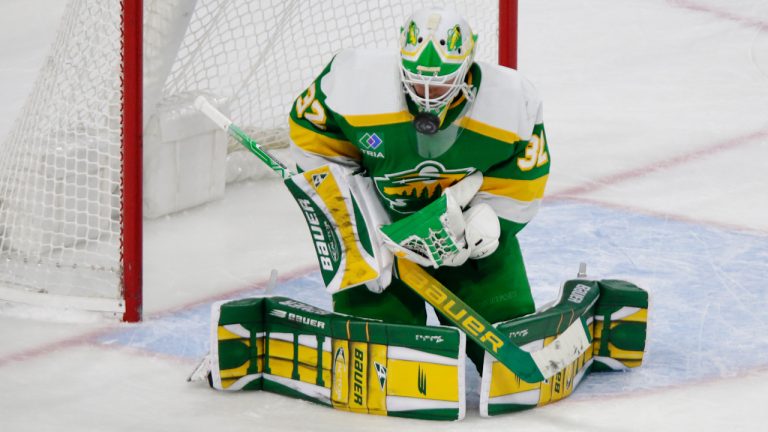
[211,297,466,420]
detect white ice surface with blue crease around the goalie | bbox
[0,0,768,432]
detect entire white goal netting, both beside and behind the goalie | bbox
[0,0,498,312]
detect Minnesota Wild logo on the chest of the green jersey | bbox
[373,160,475,214]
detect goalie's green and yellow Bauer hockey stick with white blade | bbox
[195,96,591,383]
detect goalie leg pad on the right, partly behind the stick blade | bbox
[480,279,648,416]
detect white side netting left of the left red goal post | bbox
[0,1,121,310]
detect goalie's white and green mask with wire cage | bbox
[400,9,477,134]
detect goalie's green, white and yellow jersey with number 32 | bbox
[289,50,549,235]
